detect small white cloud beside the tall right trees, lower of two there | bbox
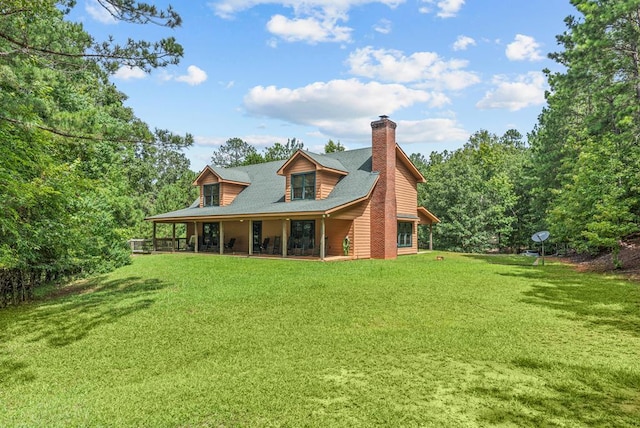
[476,71,547,111]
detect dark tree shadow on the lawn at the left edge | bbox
[0,277,167,386]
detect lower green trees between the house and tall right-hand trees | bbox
[411,130,528,252]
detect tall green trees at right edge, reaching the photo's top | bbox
[531,0,640,264]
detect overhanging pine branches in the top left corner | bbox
[0,0,183,72]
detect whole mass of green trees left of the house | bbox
[0,0,195,306]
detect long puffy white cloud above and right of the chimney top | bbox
[347,46,480,90]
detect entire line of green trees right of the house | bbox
[414,0,640,267]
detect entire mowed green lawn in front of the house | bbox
[0,253,640,427]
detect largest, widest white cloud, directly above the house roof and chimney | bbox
[244,79,435,136]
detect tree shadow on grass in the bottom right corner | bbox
[472,358,640,427]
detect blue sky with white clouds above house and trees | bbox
[72,0,576,171]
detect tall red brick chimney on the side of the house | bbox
[371,116,398,259]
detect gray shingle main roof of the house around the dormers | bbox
[149,148,378,220]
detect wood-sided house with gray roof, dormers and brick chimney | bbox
[147,116,439,259]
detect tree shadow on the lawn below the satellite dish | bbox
[470,256,640,337]
